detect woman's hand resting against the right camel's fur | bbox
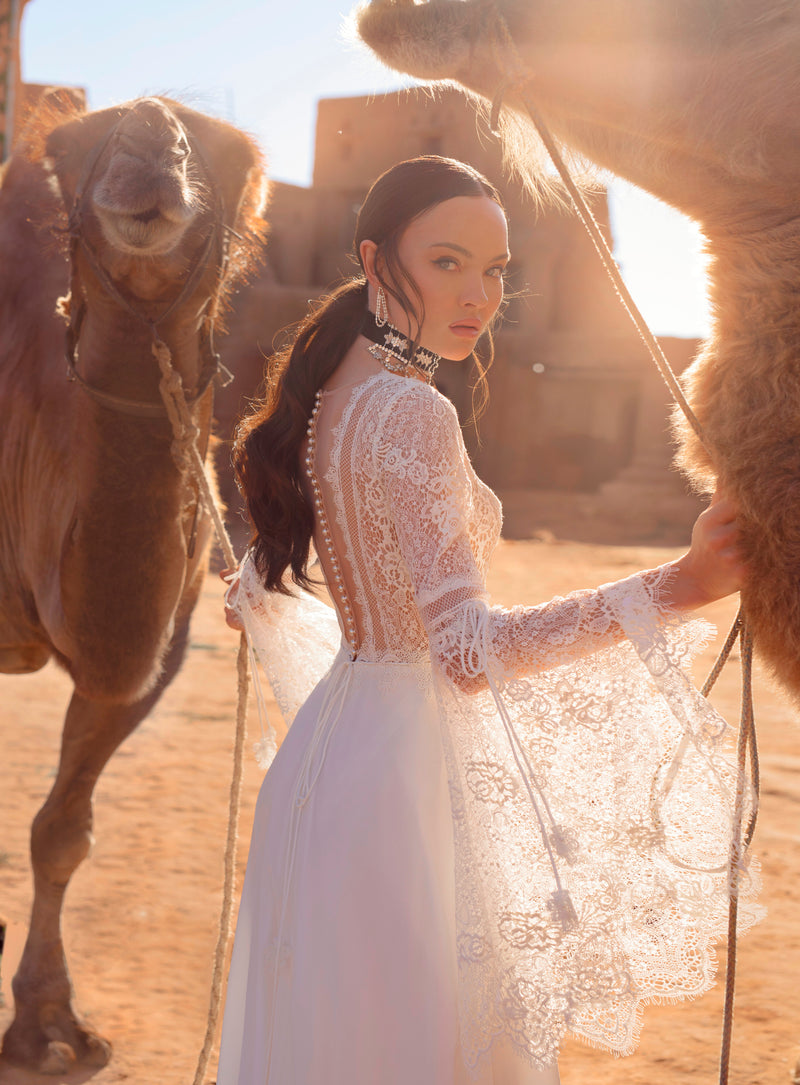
[671,494,747,610]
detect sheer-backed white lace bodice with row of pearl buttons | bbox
[316,373,501,662]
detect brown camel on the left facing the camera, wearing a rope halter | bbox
[0,94,266,1073]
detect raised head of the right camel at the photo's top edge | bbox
[355,0,800,232]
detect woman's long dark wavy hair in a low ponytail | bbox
[233,155,503,592]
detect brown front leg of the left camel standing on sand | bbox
[2,623,188,1074]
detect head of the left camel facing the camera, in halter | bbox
[39,98,265,310]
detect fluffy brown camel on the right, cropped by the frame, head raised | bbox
[357,0,800,698]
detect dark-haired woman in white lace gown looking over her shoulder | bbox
[218,156,753,1085]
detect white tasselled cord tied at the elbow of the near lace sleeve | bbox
[459,600,577,931]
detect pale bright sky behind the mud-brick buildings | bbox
[22,0,708,336]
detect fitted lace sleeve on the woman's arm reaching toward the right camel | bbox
[379,385,669,692]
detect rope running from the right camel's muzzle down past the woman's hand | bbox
[491,12,759,1085]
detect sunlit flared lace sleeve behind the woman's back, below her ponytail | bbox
[226,552,341,767]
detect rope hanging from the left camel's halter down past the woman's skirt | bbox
[152,335,249,1085]
